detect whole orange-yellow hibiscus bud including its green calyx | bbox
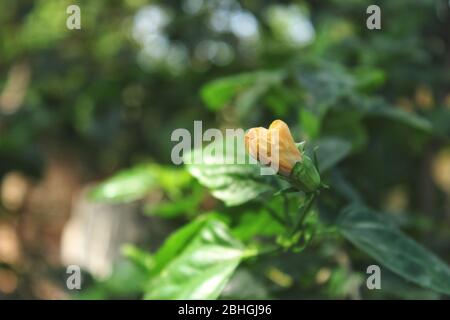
[245,120,321,192]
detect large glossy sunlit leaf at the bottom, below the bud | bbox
[145,219,244,299]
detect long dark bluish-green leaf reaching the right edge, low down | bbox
[337,205,450,295]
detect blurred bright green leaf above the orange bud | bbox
[201,71,283,110]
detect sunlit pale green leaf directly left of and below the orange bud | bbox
[184,141,275,206]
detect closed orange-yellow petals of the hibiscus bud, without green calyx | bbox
[245,120,302,177]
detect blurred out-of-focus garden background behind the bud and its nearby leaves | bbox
[0,0,450,299]
